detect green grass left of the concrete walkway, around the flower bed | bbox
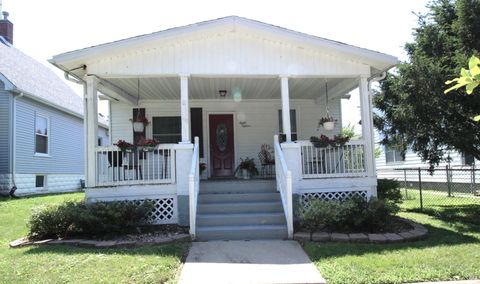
[0,193,189,283]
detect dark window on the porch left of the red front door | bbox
[152,116,182,143]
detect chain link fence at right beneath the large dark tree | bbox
[377,166,480,224]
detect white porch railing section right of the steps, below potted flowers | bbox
[297,140,367,178]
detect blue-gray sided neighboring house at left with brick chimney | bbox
[0,13,109,195]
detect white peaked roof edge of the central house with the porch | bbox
[49,16,398,75]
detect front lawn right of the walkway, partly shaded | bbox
[305,212,480,283]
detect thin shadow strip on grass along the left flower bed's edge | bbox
[24,243,190,258]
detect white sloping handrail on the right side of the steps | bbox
[274,135,293,239]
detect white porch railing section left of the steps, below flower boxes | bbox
[95,144,175,186]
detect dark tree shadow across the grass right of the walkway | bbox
[305,224,480,262]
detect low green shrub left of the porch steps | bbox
[28,201,153,239]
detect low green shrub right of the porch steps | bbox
[300,197,399,232]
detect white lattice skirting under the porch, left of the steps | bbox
[125,196,178,225]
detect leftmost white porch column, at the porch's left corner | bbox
[83,76,98,187]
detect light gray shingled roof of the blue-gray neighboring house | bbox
[0,39,83,116]
